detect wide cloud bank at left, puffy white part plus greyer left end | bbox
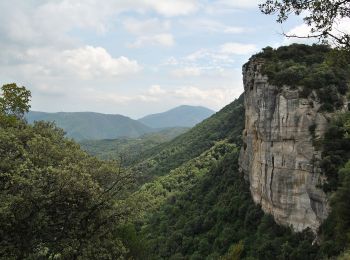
[3,46,142,80]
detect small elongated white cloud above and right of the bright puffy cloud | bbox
[128,33,175,48]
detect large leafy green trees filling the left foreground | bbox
[0,85,141,259]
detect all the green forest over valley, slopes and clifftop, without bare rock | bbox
[0,45,350,259]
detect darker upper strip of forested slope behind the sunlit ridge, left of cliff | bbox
[132,95,244,182]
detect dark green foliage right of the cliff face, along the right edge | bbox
[319,112,350,257]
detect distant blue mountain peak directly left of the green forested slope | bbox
[138,106,215,128]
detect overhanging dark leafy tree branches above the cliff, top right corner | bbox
[259,0,350,50]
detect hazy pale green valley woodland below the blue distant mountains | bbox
[80,127,188,166]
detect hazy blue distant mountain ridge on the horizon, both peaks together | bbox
[25,105,215,141]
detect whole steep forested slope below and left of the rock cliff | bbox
[131,95,318,259]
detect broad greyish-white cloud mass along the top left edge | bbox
[0,0,199,46]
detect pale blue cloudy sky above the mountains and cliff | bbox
[0,0,312,119]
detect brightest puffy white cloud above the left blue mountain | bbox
[62,46,141,79]
